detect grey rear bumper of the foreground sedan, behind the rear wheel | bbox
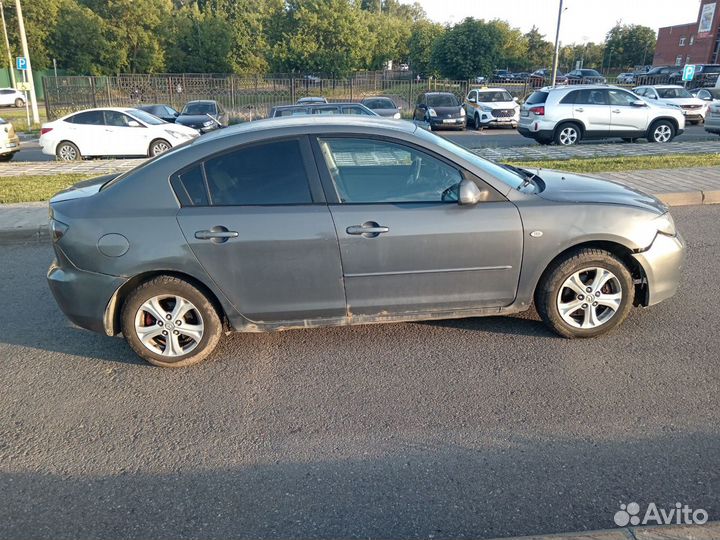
[47,247,127,334]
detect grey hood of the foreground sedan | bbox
[530,169,667,214]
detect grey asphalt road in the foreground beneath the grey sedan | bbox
[0,206,720,539]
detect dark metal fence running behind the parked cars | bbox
[42,72,652,122]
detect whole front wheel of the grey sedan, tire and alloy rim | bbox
[535,248,635,338]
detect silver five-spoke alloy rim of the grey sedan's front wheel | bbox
[557,267,623,329]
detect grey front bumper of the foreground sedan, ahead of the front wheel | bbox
[633,233,685,306]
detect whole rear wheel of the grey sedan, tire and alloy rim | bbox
[120,276,222,367]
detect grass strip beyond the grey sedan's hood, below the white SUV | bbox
[509,154,720,173]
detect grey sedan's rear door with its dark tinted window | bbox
[171,136,345,322]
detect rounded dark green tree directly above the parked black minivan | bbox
[432,17,505,79]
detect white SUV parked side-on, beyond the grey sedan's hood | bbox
[518,85,685,146]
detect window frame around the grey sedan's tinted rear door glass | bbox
[168,135,326,208]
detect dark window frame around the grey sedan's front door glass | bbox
[310,132,500,206]
